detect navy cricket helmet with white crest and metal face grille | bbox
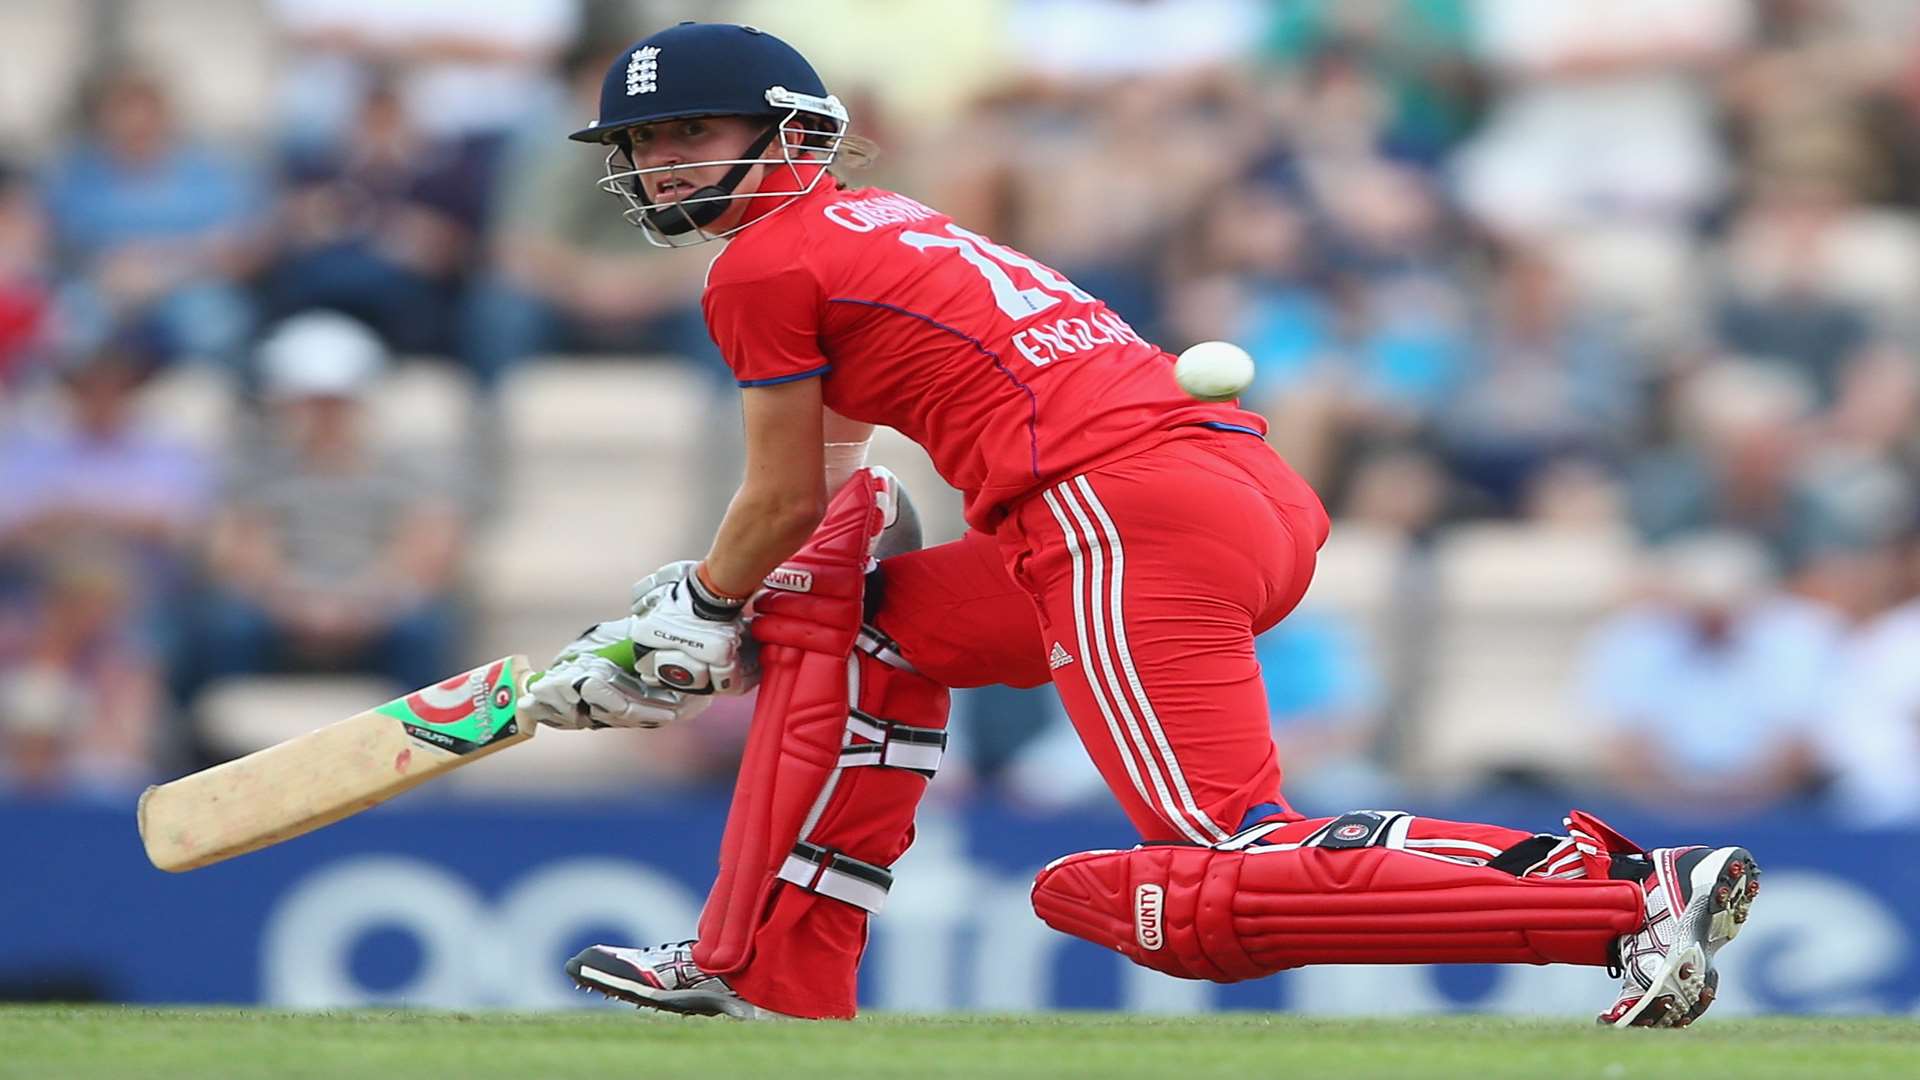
[570,23,847,246]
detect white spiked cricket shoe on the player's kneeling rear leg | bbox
[1599,847,1761,1028]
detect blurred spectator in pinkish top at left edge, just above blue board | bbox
[0,542,163,798]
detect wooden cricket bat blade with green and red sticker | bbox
[138,655,534,872]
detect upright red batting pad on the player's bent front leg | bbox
[693,471,947,1019]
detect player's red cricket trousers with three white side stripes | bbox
[877,427,1329,844]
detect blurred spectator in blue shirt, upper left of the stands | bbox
[40,67,263,361]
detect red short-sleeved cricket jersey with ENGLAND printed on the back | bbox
[703,177,1267,530]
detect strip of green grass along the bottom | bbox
[0,1005,1920,1080]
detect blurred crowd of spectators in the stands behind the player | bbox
[0,0,1920,822]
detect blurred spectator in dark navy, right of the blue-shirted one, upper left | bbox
[265,85,484,356]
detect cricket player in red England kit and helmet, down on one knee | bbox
[522,23,1759,1026]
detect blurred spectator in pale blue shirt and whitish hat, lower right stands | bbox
[1576,534,1847,813]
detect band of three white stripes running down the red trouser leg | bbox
[1043,477,1227,844]
